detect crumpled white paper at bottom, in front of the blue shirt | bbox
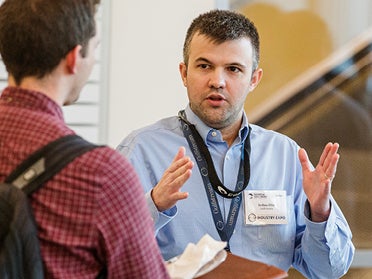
[167,234,226,279]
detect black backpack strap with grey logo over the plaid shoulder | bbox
[5,135,98,194]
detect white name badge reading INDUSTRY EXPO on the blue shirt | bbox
[244,190,288,225]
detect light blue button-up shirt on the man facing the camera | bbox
[118,107,354,278]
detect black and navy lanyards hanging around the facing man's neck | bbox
[178,111,251,250]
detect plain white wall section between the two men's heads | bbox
[106,0,219,147]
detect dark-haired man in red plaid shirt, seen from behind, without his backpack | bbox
[0,0,169,279]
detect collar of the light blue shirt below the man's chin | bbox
[185,105,248,143]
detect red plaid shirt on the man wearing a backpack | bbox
[0,87,168,279]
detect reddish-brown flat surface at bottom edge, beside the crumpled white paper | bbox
[198,254,288,279]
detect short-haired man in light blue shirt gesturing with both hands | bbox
[118,10,354,278]
